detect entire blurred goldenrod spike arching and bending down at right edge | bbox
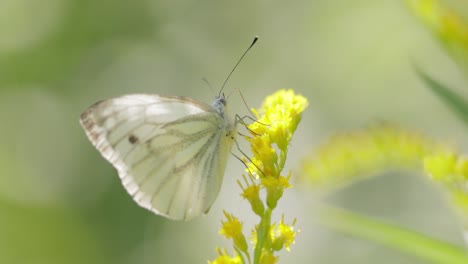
[303,125,468,244]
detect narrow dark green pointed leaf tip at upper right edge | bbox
[415,66,468,125]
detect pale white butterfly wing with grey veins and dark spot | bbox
[80,95,234,220]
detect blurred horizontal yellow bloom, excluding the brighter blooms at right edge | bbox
[302,124,448,187]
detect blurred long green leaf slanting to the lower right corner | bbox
[318,207,468,264]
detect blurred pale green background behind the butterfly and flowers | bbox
[0,0,468,264]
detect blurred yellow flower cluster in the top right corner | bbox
[407,0,468,71]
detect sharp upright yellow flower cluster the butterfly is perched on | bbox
[210,90,308,264]
